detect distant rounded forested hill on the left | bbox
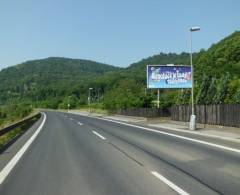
[0,57,119,106]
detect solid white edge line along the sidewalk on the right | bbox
[73,113,240,154]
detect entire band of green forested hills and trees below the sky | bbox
[0,31,240,109]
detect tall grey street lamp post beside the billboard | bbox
[189,27,200,130]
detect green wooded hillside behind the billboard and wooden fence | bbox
[101,32,240,109]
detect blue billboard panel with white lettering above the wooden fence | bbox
[147,65,192,89]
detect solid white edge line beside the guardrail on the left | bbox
[0,113,46,185]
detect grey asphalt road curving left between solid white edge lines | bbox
[0,111,240,195]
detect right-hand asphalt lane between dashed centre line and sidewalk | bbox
[65,112,240,194]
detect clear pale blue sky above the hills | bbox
[0,0,240,69]
